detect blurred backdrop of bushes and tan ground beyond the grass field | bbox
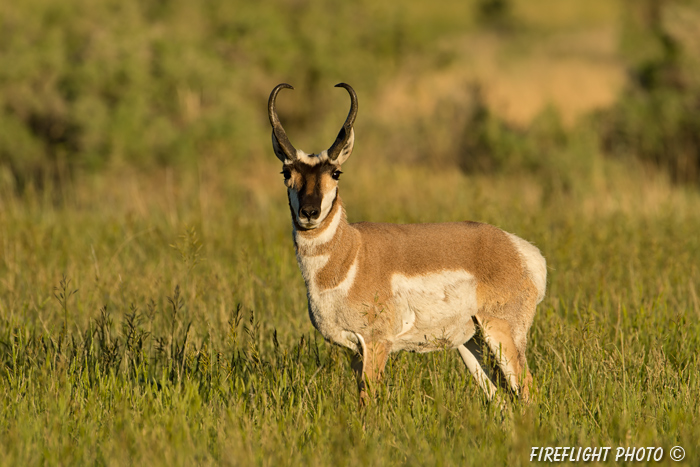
[0,0,700,196]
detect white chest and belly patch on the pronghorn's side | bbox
[299,249,477,352]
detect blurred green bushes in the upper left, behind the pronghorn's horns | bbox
[0,0,464,189]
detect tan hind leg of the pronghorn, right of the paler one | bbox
[475,314,532,402]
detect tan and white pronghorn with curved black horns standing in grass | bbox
[268,83,547,403]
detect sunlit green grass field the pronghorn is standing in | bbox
[0,159,700,465]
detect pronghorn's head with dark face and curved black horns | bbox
[267,83,357,230]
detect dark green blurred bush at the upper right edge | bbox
[599,0,700,183]
